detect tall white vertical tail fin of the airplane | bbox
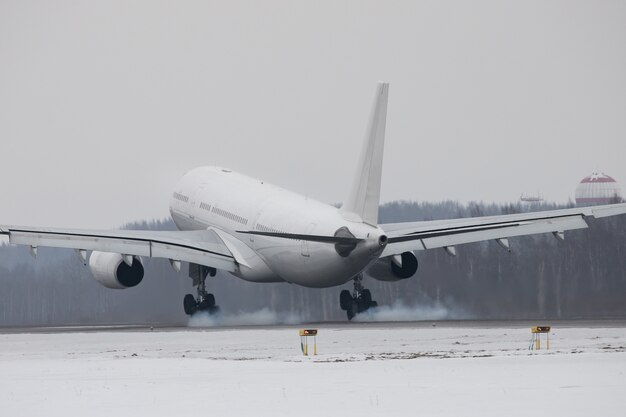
[341,82,389,226]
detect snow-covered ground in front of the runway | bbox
[0,323,626,417]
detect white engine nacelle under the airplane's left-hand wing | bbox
[89,251,144,289]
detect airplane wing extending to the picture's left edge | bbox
[0,225,237,272]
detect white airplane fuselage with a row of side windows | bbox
[170,167,385,288]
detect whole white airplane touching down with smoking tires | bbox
[0,83,626,319]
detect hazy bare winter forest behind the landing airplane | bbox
[0,201,626,326]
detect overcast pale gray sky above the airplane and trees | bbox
[0,0,626,228]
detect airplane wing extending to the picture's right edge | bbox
[380,203,626,257]
